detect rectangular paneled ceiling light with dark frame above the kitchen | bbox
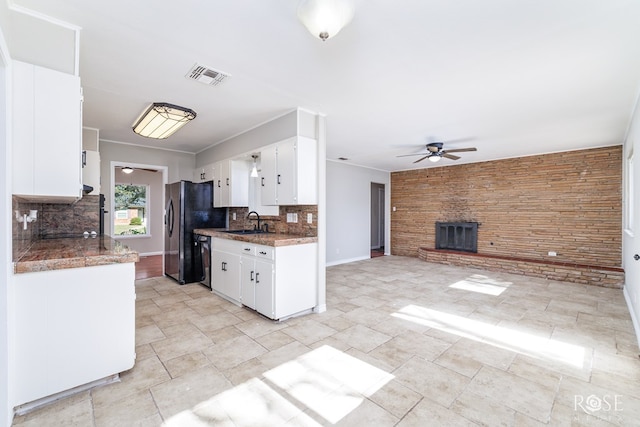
[133,102,196,139]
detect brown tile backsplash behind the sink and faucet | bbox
[229,205,318,237]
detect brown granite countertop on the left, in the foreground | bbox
[13,236,139,273]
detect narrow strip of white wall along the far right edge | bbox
[622,94,640,346]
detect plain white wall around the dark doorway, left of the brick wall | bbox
[326,160,391,265]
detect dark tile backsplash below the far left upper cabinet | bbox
[11,196,100,260]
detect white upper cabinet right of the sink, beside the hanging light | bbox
[260,136,318,205]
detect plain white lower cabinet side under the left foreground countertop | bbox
[12,263,135,405]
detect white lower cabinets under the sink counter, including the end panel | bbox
[211,238,318,320]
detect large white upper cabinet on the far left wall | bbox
[12,61,82,202]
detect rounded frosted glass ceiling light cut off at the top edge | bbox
[298,0,354,41]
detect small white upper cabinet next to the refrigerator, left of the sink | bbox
[213,160,250,208]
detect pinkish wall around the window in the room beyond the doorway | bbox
[115,169,164,255]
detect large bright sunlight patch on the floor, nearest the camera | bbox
[163,345,394,427]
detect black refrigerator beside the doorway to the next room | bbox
[164,181,227,285]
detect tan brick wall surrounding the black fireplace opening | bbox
[391,146,622,284]
